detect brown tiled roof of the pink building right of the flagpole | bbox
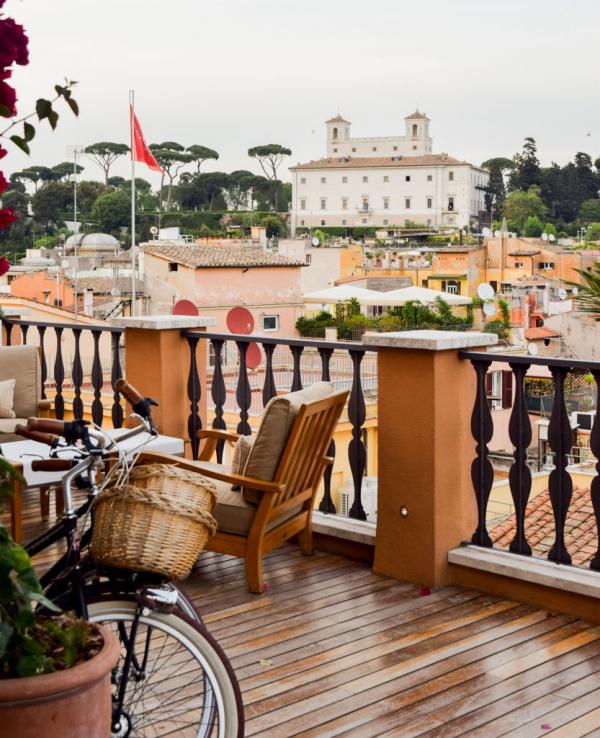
[140,243,305,269]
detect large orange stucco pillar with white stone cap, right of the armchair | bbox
[364,331,497,586]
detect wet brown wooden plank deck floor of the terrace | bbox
[10,484,600,738]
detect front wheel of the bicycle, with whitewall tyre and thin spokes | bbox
[89,600,244,738]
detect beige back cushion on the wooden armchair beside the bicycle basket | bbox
[243,382,333,505]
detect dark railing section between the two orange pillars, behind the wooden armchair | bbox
[183,331,377,520]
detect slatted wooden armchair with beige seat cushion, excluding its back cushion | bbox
[197,391,348,593]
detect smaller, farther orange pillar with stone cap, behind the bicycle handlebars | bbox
[114,315,215,452]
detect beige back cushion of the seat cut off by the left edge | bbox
[0,346,41,418]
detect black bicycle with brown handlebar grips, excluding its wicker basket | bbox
[18,379,244,738]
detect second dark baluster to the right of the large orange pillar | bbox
[508,364,531,556]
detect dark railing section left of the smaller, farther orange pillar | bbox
[2,318,123,428]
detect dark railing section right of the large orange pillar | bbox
[461,352,600,571]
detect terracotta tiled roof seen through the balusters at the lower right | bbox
[490,487,598,566]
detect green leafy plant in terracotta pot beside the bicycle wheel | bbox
[0,458,119,738]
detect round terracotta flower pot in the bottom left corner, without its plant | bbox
[0,627,119,738]
